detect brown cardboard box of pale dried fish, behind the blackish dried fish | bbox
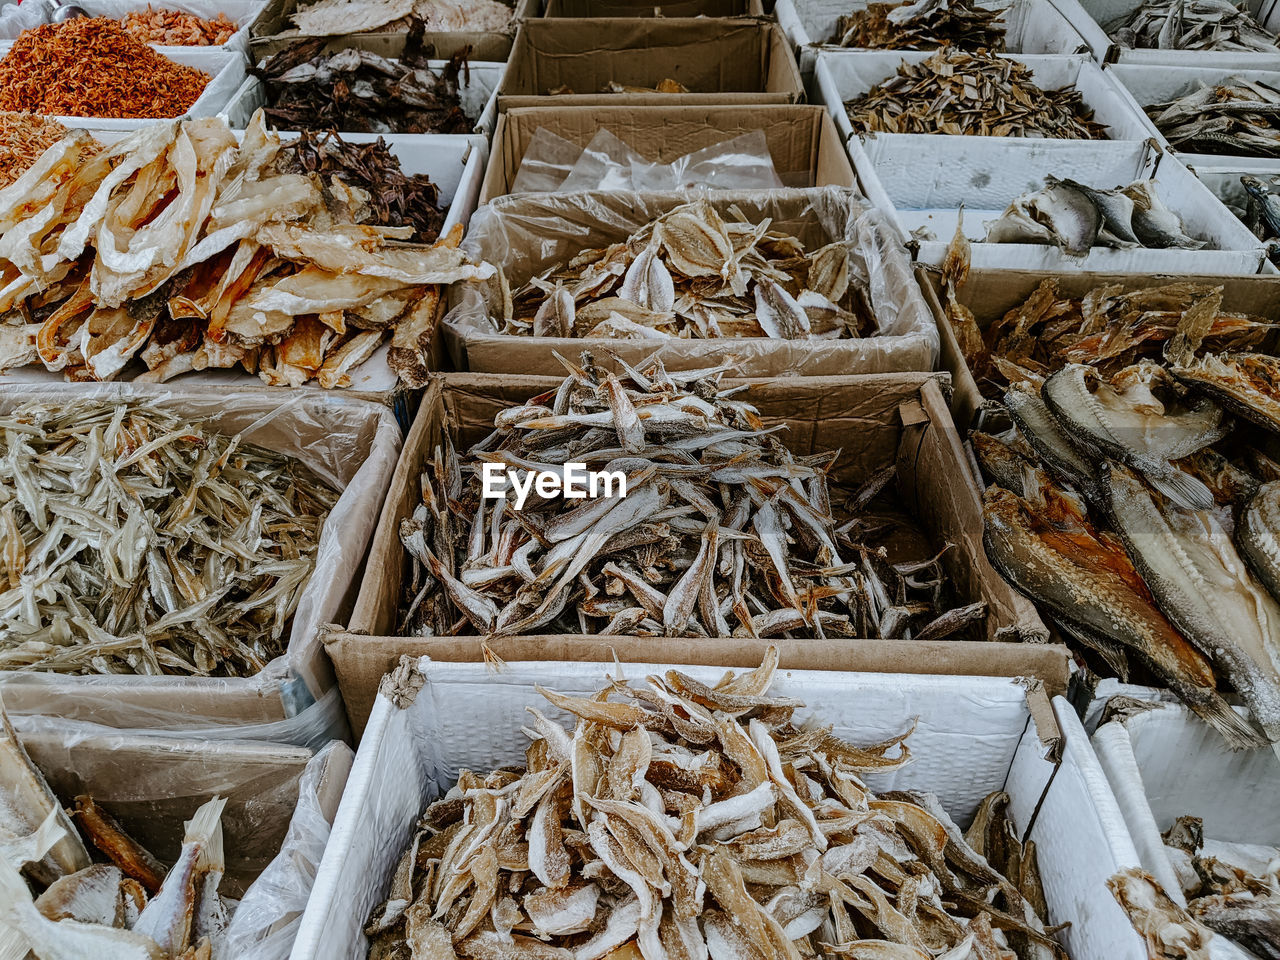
[250,0,540,63]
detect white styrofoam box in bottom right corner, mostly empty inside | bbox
[1093,704,1280,960]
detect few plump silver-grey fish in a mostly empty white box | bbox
[987,177,1204,256]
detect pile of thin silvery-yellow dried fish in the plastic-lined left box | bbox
[0,402,338,676]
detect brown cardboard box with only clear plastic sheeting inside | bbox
[479,104,865,204]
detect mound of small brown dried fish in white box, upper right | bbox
[845,47,1106,140]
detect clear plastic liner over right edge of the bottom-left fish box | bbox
[224,744,353,960]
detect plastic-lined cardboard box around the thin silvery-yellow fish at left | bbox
[0,383,401,724]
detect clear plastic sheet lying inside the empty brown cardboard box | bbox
[511,127,785,193]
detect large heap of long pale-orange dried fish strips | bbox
[0,111,492,387]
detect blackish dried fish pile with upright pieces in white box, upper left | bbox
[250,18,474,133]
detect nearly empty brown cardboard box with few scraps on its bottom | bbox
[498,18,804,111]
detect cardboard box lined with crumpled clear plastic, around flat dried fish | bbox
[444,187,940,376]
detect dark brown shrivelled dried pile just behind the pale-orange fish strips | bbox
[278,131,445,243]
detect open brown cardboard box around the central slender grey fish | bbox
[325,374,1049,731]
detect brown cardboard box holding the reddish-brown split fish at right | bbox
[916,269,1280,433]
